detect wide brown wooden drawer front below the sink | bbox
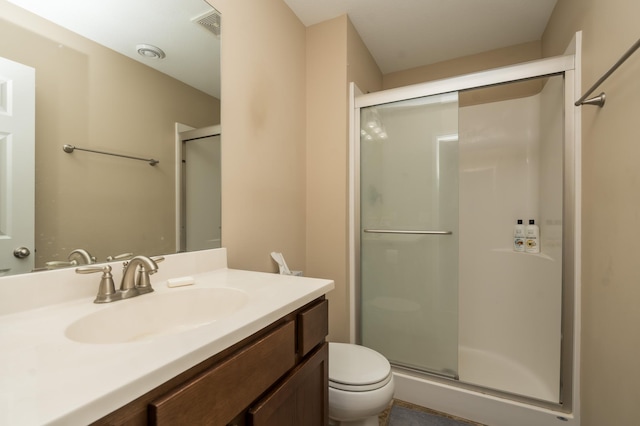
[149,321,295,425]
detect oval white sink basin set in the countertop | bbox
[65,287,248,344]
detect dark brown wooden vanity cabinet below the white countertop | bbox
[100,298,328,426]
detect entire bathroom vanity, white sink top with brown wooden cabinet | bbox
[0,249,333,425]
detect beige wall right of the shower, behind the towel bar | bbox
[542,0,640,426]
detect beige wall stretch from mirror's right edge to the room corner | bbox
[208,0,306,272]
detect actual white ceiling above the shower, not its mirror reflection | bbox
[284,0,557,74]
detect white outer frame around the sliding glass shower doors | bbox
[349,55,580,413]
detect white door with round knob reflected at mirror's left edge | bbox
[0,58,35,276]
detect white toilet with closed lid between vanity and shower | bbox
[329,342,395,426]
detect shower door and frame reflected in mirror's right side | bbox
[179,126,221,251]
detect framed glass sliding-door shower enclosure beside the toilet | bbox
[354,56,575,424]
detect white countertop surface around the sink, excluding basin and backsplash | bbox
[0,252,334,426]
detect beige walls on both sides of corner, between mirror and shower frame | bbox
[209,0,382,341]
